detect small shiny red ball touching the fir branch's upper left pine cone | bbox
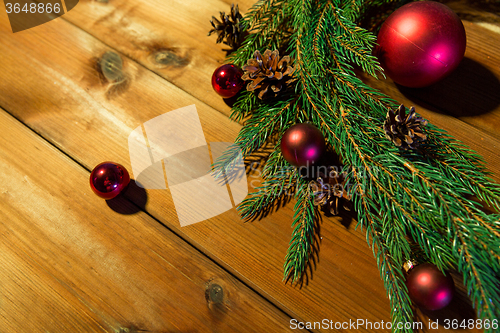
[212,64,245,98]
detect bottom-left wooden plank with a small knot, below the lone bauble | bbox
[0,110,300,332]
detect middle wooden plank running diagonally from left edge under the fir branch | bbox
[0,9,498,331]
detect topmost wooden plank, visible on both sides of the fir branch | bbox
[59,0,500,138]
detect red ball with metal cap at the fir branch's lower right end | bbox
[406,263,455,310]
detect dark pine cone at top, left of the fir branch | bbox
[208,4,243,50]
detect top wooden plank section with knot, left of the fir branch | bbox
[60,0,246,115]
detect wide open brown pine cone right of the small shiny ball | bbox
[241,50,295,99]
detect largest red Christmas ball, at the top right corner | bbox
[375,1,467,87]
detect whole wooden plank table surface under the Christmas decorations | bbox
[0,0,500,333]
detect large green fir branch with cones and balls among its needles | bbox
[215,0,500,323]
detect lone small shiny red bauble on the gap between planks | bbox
[90,162,130,200]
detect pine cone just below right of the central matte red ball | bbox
[309,167,351,215]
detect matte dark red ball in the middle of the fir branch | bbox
[281,124,325,167]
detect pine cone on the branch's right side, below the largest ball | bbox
[384,104,427,149]
